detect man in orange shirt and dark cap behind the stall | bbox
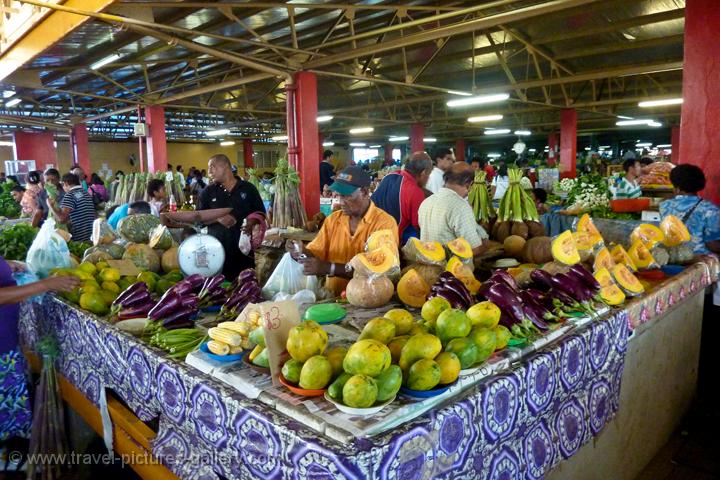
[288,167,398,296]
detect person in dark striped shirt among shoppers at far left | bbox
[47,173,95,242]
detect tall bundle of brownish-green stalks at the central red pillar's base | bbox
[272,158,307,228]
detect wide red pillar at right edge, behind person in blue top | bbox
[672,0,720,203]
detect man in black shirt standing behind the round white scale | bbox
[198,154,265,280]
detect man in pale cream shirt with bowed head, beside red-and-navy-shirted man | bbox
[418,162,488,255]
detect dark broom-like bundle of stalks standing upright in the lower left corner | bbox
[26,337,68,479]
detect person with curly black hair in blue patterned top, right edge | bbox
[660,163,720,254]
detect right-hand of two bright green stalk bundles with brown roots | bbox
[491,168,545,242]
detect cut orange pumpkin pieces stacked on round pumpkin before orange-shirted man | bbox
[345,231,400,308]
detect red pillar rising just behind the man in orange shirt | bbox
[288,72,322,217]
